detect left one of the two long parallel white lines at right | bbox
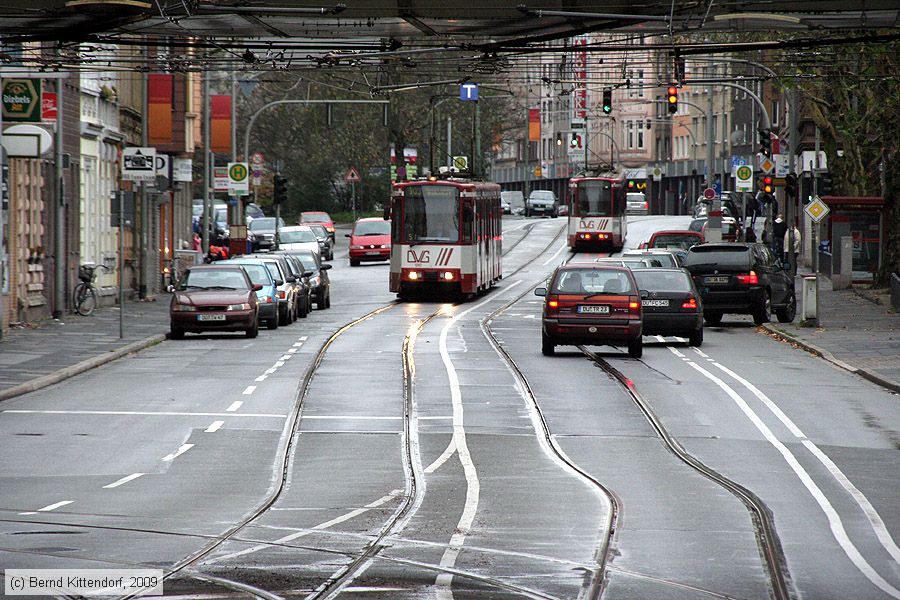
[688,362,900,598]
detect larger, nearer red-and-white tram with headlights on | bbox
[385,174,503,299]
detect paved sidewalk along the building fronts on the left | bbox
[0,293,169,400]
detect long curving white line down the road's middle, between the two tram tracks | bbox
[435,286,522,598]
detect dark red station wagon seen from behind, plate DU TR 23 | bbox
[534,264,643,358]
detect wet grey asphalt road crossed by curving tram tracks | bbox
[0,217,900,598]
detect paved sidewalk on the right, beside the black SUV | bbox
[764,269,900,393]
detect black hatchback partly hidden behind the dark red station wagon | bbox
[632,268,703,346]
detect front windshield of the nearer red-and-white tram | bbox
[403,185,459,244]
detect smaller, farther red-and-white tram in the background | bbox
[568,172,628,251]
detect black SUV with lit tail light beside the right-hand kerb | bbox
[684,242,797,325]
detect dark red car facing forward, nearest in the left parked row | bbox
[169,264,262,340]
